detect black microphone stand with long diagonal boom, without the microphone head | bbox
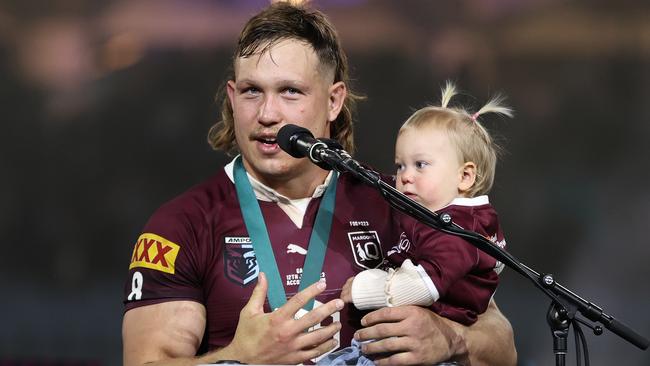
[316,148,649,366]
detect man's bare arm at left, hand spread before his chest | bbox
[122,273,343,366]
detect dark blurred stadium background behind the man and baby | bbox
[0,0,650,366]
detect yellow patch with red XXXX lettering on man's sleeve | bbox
[129,233,181,274]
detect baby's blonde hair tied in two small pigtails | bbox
[398,81,513,197]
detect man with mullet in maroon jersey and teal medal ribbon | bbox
[122,3,516,365]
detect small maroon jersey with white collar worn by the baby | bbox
[386,196,506,325]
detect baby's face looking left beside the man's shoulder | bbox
[395,127,462,211]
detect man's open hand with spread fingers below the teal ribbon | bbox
[220,273,343,364]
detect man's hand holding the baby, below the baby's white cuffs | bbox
[354,306,469,366]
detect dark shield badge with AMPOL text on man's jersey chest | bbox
[223,236,260,286]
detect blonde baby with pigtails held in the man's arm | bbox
[341,82,512,325]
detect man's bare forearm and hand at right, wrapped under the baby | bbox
[355,301,517,366]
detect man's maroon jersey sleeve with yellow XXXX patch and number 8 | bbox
[124,204,203,310]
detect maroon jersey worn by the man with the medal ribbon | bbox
[124,170,398,360]
